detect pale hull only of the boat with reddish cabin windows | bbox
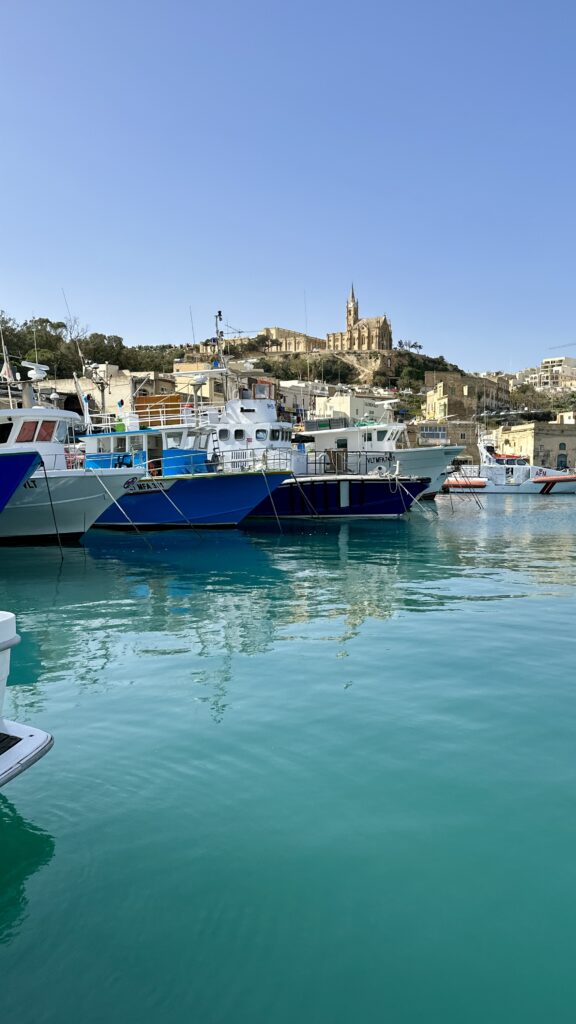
[0,469,138,541]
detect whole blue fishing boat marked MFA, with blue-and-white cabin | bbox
[81,422,289,529]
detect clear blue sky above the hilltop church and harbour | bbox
[0,0,576,370]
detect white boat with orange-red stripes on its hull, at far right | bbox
[443,437,576,495]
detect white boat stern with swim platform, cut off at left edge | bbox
[0,611,53,786]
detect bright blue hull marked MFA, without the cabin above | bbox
[94,472,286,529]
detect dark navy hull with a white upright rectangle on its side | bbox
[241,476,429,520]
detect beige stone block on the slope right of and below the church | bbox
[422,371,509,420]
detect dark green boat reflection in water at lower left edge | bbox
[0,797,54,944]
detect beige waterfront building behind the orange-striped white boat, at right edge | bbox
[496,414,576,469]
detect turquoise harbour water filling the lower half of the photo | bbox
[0,496,576,1024]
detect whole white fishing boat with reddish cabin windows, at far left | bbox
[0,407,145,543]
